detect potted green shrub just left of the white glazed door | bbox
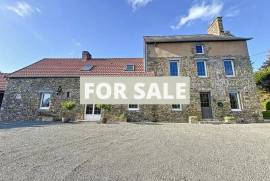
[61,101,76,123]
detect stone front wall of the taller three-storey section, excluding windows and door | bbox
[146,42,261,122]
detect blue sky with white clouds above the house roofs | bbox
[0,0,270,72]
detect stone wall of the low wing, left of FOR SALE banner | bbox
[0,78,84,120]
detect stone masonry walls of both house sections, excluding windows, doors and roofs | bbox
[0,17,262,123]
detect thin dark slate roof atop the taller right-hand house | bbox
[144,34,252,43]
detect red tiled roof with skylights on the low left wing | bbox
[8,58,154,78]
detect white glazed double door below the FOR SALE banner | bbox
[84,104,101,121]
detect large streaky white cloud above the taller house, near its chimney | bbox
[171,0,223,29]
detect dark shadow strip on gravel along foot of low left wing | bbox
[0,121,61,129]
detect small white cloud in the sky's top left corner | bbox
[5,1,41,17]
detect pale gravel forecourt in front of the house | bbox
[0,122,270,181]
